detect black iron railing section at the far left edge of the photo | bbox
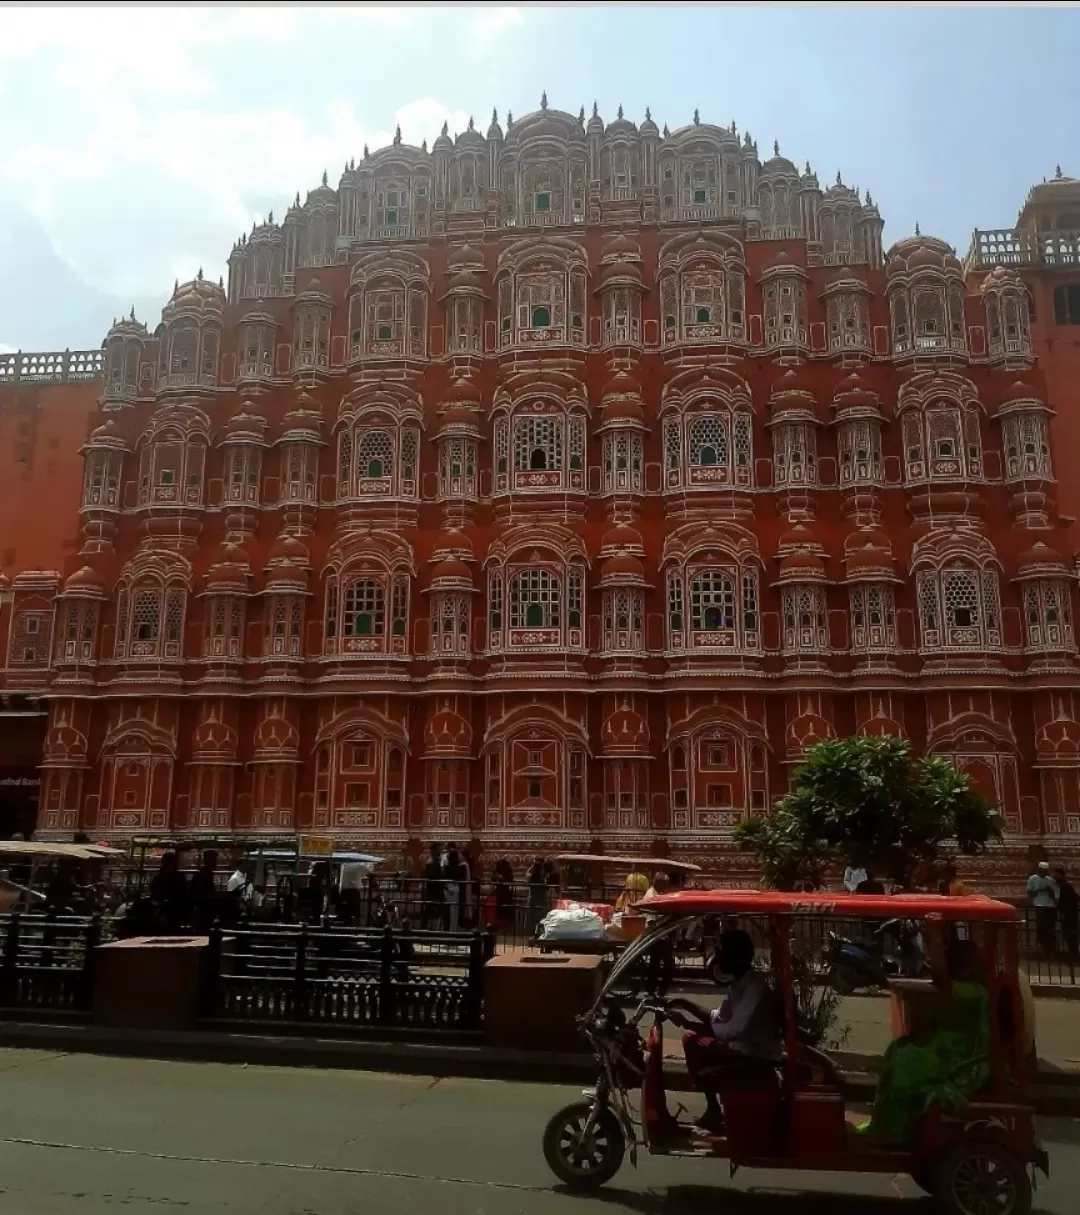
[0,915,101,1016]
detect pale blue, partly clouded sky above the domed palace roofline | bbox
[0,4,1080,350]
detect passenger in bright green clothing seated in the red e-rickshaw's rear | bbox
[859,938,990,1146]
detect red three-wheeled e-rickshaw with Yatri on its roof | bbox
[543,889,1048,1215]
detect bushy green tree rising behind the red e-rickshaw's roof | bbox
[735,738,1001,889]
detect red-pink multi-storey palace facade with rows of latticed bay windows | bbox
[0,98,1080,881]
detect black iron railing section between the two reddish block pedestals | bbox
[200,925,496,1033]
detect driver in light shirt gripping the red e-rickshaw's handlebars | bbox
[666,928,782,1134]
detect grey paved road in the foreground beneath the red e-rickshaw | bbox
[0,1051,1080,1215]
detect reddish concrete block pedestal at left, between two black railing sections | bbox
[94,937,224,1029]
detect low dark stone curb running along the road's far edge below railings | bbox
[0,1022,1080,1118]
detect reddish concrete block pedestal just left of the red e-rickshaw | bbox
[484,954,601,1051]
